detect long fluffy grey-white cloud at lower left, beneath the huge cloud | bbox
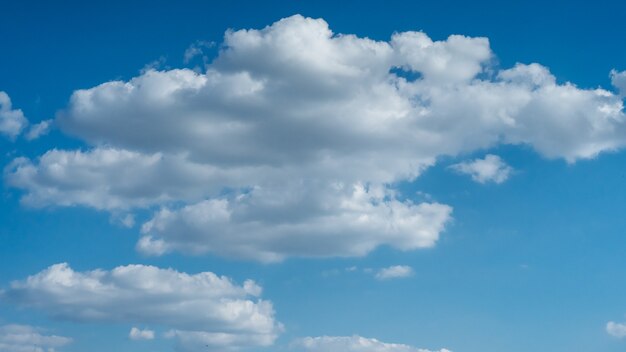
[4,264,282,350]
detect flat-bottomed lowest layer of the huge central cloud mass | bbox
[138,185,451,261]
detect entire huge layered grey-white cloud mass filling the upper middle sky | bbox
[6,16,626,261]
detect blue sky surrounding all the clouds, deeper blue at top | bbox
[0,1,626,352]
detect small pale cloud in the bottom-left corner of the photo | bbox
[0,325,72,352]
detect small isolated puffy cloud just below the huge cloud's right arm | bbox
[450,154,513,183]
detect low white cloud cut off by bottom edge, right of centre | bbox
[293,335,451,352]
